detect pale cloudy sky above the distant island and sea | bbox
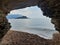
[10,6,48,18]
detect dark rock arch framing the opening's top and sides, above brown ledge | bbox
[0,0,60,39]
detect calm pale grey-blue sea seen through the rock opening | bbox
[9,18,56,39]
